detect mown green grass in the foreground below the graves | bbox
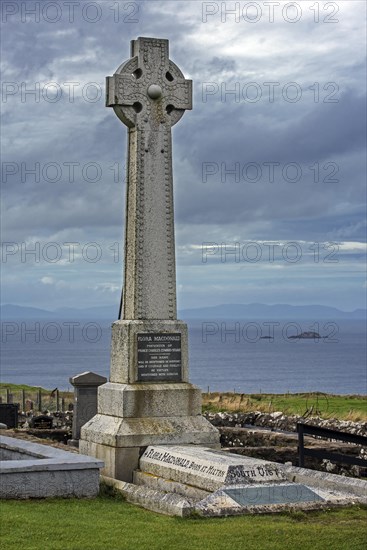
[0,496,367,550]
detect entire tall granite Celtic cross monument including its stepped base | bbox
[79,37,219,481]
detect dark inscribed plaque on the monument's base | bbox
[137,332,181,382]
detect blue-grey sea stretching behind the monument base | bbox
[1,319,367,395]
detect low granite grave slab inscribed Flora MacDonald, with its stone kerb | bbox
[103,446,367,517]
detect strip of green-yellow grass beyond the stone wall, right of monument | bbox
[203,392,367,421]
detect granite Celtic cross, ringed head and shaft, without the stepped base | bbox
[106,38,192,320]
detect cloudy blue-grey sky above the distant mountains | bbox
[1,0,366,310]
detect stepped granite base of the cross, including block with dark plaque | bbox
[79,320,219,482]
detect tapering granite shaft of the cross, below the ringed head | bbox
[122,127,177,320]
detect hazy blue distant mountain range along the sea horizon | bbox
[0,304,367,321]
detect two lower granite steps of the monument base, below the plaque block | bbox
[79,383,219,482]
